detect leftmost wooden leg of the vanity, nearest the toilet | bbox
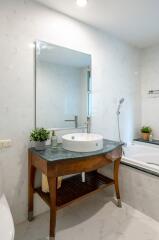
[28,153,36,221]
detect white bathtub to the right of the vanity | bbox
[122,142,159,176]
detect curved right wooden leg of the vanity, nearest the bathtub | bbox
[114,159,122,208]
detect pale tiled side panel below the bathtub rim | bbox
[120,165,159,221]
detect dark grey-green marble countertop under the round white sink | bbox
[30,139,123,162]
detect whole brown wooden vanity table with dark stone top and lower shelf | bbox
[28,140,122,240]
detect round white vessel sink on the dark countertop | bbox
[62,133,103,152]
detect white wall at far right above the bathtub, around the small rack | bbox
[141,45,159,139]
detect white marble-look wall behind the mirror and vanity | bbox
[0,0,140,222]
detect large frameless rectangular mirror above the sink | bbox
[35,41,91,129]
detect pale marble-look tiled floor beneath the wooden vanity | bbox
[15,192,159,240]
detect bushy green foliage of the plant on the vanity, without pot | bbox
[30,128,50,142]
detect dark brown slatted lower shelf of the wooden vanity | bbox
[35,171,114,209]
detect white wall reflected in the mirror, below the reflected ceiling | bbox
[36,61,87,129]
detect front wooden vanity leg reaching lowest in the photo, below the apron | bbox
[48,177,57,240]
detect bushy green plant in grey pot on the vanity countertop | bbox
[30,128,50,150]
